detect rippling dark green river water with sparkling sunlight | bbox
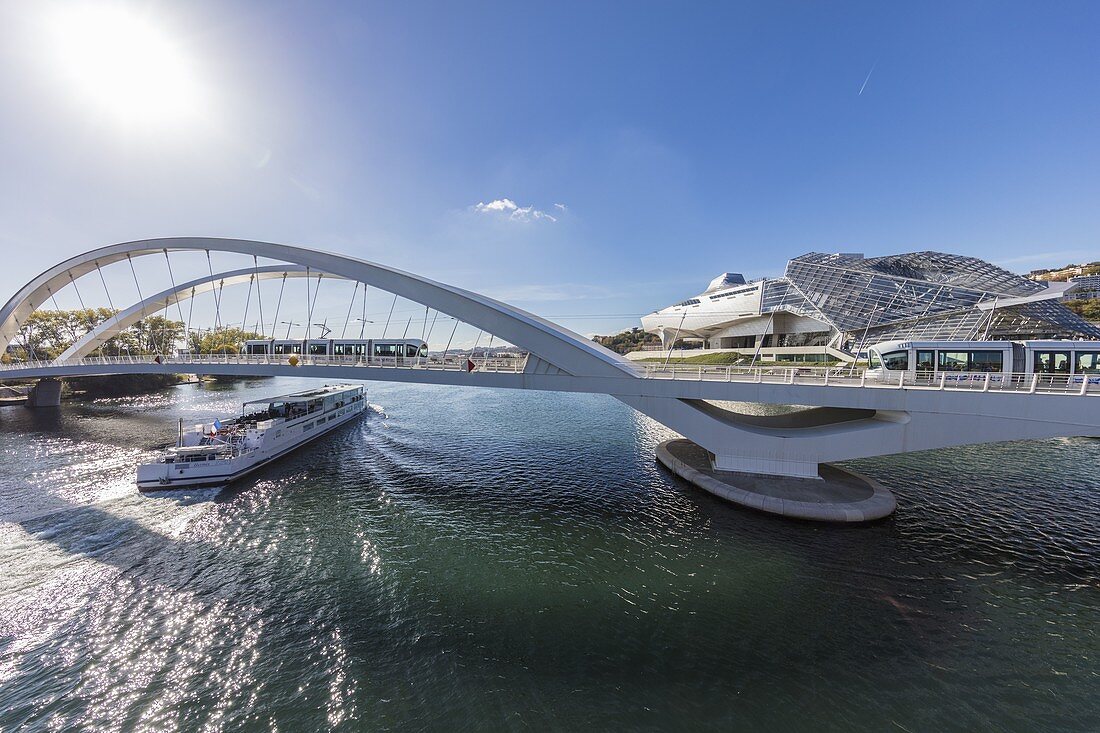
[0,380,1100,731]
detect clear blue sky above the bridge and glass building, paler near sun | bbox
[0,0,1100,333]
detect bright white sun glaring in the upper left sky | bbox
[47,2,202,127]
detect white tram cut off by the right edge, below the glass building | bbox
[867,341,1100,384]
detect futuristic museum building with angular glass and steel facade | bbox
[641,252,1100,361]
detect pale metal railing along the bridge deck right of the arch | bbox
[637,364,1100,395]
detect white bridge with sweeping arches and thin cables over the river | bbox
[0,238,1100,501]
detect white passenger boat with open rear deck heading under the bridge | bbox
[138,384,366,491]
